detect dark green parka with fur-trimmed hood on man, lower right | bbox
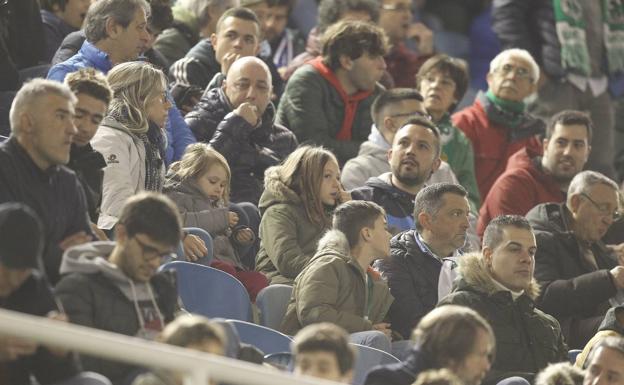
[439,253,568,385]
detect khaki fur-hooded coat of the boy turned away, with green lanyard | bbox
[280,230,394,335]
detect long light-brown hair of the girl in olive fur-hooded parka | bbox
[278,146,338,227]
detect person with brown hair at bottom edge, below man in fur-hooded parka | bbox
[365,306,496,385]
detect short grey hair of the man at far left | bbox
[9,78,78,135]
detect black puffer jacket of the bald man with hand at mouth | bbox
[185,88,297,205]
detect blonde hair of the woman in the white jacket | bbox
[107,62,167,134]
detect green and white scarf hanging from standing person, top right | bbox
[553,0,624,76]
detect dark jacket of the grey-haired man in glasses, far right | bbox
[526,203,617,349]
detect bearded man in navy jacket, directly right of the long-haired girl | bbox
[351,117,440,234]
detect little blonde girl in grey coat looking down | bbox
[163,143,268,301]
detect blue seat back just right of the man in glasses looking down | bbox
[160,261,251,321]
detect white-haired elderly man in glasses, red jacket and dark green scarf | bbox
[452,49,544,197]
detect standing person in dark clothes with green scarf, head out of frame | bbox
[492,0,624,178]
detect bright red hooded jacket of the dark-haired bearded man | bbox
[477,148,566,236]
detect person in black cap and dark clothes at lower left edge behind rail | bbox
[0,203,77,384]
